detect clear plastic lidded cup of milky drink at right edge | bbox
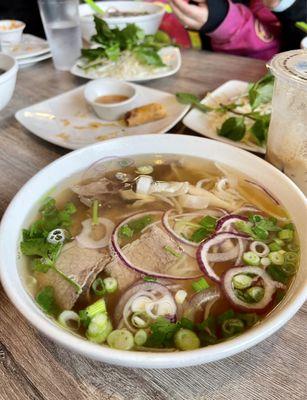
[266,50,307,195]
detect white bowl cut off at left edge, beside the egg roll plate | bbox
[0,53,18,111]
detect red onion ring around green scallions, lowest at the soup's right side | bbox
[221,266,277,312]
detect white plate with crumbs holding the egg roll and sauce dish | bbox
[15,85,189,150]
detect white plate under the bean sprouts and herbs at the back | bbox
[70,46,181,82]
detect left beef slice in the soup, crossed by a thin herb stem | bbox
[39,241,110,310]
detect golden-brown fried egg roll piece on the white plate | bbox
[125,103,166,126]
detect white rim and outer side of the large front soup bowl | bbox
[0,134,307,368]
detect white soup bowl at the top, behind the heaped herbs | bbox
[79,1,165,42]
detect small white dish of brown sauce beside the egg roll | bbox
[84,79,137,121]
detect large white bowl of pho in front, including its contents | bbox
[0,135,307,368]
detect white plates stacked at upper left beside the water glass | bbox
[2,33,50,61]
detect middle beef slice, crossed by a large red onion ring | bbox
[105,225,183,290]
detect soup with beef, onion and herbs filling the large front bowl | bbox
[21,155,299,351]
